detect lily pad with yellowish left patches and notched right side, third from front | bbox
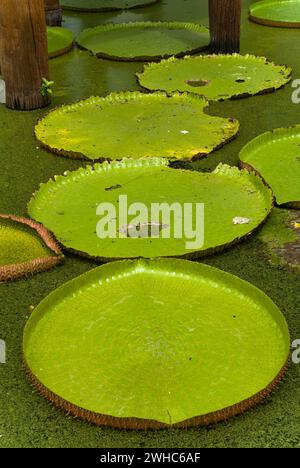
[35,92,239,160]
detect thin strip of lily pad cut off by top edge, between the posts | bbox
[61,0,159,11]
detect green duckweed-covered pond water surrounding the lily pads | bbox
[0,0,300,448]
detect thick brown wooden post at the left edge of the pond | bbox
[0,0,50,110]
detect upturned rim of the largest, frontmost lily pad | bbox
[23,259,290,430]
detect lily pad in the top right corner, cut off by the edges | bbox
[250,0,300,28]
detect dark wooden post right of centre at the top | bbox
[209,0,242,54]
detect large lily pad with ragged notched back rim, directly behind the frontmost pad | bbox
[28,159,272,261]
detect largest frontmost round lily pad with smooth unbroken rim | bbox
[23,260,290,429]
